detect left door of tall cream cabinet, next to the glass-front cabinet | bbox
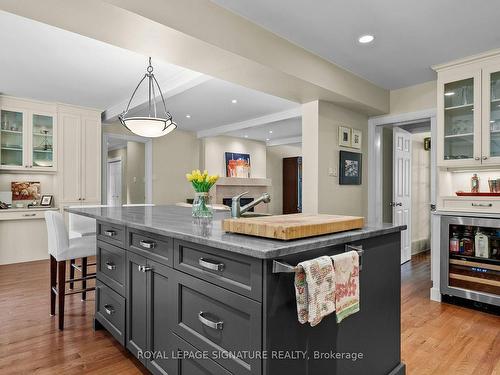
[58,113,82,202]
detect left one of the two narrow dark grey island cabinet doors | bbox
[126,252,150,365]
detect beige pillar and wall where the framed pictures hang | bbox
[302,101,368,217]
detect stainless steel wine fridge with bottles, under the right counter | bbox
[441,216,500,306]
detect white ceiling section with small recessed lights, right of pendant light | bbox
[131,78,298,131]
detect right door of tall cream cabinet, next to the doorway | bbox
[81,116,101,203]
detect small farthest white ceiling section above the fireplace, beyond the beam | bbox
[226,117,302,142]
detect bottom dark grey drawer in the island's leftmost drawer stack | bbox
[95,280,125,345]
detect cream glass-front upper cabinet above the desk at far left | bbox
[0,98,57,172]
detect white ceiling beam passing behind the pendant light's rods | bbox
[101,70,213,122]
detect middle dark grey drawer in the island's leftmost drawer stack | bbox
[96,241,126,295]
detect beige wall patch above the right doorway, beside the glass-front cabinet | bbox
[389,81,437,114]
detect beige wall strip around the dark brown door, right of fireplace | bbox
[266,143,302,215]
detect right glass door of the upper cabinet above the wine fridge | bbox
[482,62,500,164]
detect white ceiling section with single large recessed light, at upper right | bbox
[212,0,500,89]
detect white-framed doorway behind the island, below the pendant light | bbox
[102,133,153,206]
